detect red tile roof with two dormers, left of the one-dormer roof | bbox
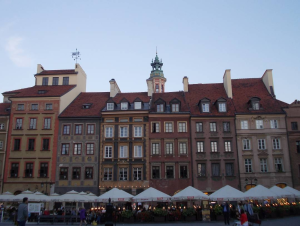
[186,83,234,116]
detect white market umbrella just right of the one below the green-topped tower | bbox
[171,186,208,201]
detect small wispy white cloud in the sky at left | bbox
[5,37,33,67]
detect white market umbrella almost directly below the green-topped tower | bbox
[133,187,171,202]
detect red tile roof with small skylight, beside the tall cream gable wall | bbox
[59,92,109,117]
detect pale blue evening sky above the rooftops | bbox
[0,0,300,103]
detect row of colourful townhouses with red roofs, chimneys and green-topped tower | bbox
[0,53,300,195]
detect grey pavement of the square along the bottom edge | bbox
[0,216,300,226]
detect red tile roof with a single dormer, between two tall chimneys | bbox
[232,78,288,114]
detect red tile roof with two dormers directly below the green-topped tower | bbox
[150,91,190,112]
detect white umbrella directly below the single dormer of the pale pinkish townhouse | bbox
[244,184,280,200]
